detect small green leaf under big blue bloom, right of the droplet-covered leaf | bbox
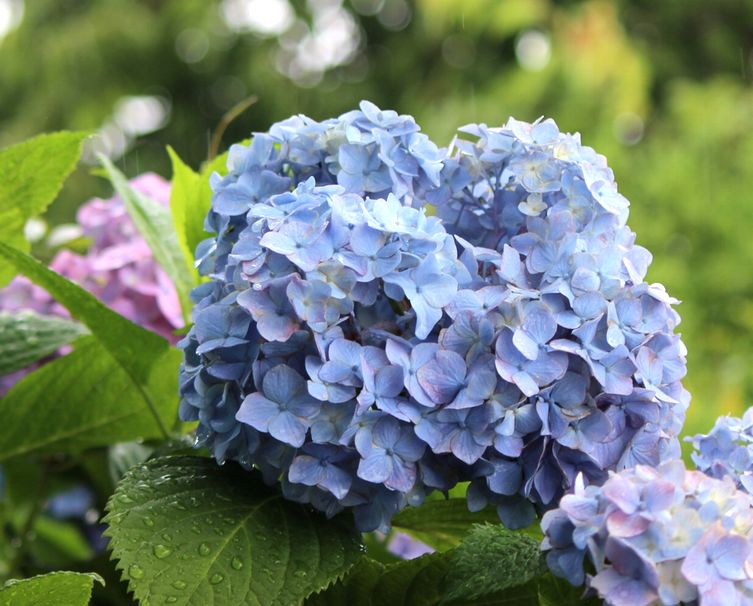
[392,499,499,551]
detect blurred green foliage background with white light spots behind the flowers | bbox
[0,0,753,442]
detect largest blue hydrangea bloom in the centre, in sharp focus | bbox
[180,102,688,530]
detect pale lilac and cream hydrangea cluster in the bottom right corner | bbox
[542,460,753,606]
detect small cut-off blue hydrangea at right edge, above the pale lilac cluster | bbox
[686,408,753,494]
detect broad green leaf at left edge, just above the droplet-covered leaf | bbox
[0,337,180,461]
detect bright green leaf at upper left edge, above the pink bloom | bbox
[0,132,87,286]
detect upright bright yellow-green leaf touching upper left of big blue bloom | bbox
[167,147,212,274]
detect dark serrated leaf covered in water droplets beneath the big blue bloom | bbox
[105,457,361,606]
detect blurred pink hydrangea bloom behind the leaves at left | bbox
[0,173,183,395]
